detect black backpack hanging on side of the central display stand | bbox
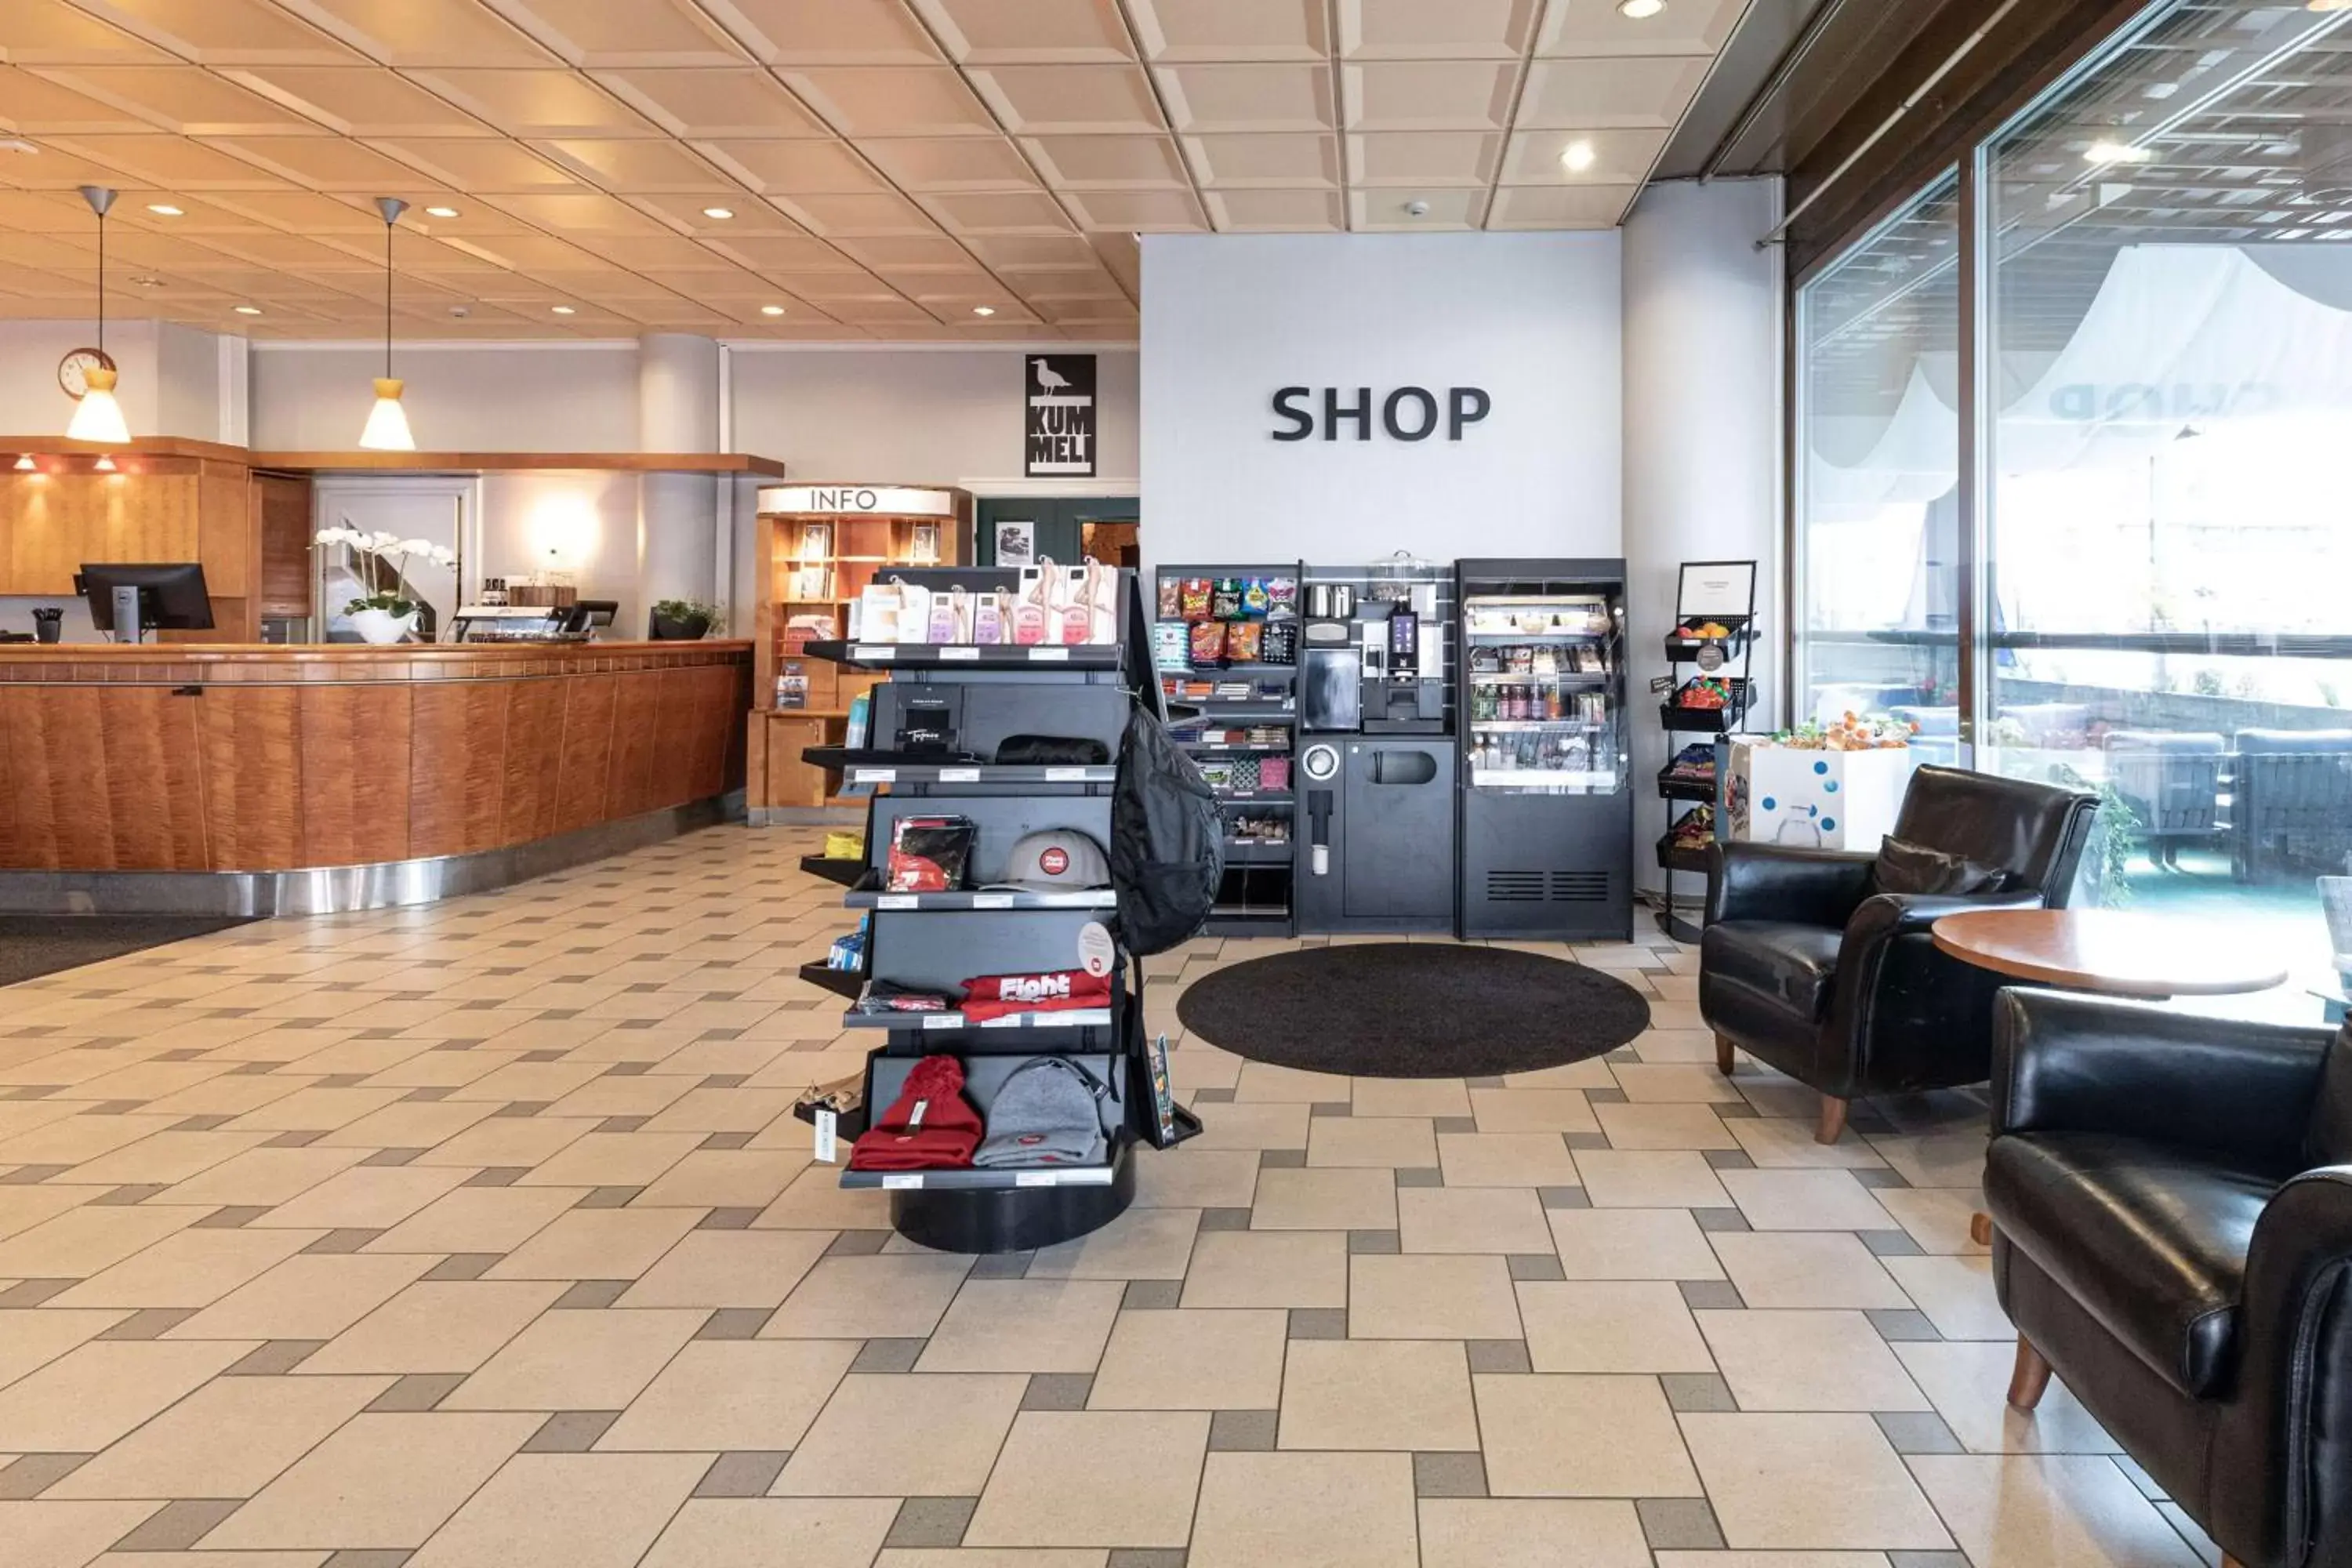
[1110,708,1225,956]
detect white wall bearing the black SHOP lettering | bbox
[1143,233,1623,562]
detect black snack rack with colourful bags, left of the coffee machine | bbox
[1152,562,1305,935]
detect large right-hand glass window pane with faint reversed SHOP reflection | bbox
[1976,0,2352,985]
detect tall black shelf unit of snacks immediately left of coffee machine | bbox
[1152,562,1305,935]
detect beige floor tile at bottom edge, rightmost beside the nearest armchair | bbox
[1910,1455,2199,1568]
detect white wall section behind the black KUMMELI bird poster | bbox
[729,346,1143,496]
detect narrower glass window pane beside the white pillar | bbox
[1797,174,1962,762]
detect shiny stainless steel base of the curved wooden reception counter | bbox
[0,789,743,916]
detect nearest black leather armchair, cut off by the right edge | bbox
[1985,989,2352,1568]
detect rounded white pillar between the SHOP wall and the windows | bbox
[1625,181,1785,893]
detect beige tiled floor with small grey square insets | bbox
[0,829,2211,1568]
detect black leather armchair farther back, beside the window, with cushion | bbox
[1698,767,2098,1142]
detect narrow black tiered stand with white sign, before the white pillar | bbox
[1658,562,1757,942]
